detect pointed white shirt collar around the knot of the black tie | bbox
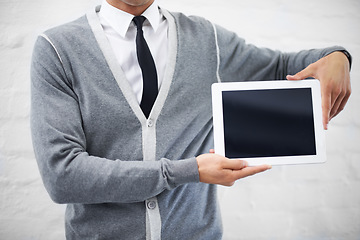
[99,0,162,37]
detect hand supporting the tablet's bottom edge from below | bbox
[196,151,271,186]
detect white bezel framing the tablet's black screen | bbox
[212,79,326,166]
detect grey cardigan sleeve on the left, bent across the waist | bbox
[31,35,199,204]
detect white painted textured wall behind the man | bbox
[0,0,360,240]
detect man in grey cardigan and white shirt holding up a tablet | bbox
[31,0,350,239]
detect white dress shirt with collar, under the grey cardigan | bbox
[98,0,168,103]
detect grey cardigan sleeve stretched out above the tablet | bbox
[216,23,351,82]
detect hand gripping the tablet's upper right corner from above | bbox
[286,52,351,129]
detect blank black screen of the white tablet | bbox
[222,88,316,158]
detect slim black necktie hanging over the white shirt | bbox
[133,16,158,118]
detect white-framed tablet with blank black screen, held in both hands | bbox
[212,79,326,166]
